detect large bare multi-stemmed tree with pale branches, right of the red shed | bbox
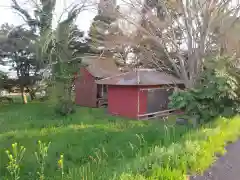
[115,0,239,88]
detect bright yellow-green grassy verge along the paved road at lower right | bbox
[117,117,240,180]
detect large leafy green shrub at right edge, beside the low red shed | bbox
[169,57,239,121]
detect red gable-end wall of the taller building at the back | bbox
[75,68,97,107]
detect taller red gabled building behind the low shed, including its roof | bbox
[75,57,120,107]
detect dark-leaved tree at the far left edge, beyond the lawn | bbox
[0,24,40,103]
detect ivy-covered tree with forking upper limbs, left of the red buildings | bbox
[12,0,92,111]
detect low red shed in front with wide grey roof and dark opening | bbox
[96,69,183,119]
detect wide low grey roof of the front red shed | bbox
[96,69,183,85]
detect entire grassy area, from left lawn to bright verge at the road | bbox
[0,102,240,180]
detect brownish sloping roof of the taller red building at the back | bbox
[83,56,121,78]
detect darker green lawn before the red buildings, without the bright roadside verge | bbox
[0,103,188,177]
